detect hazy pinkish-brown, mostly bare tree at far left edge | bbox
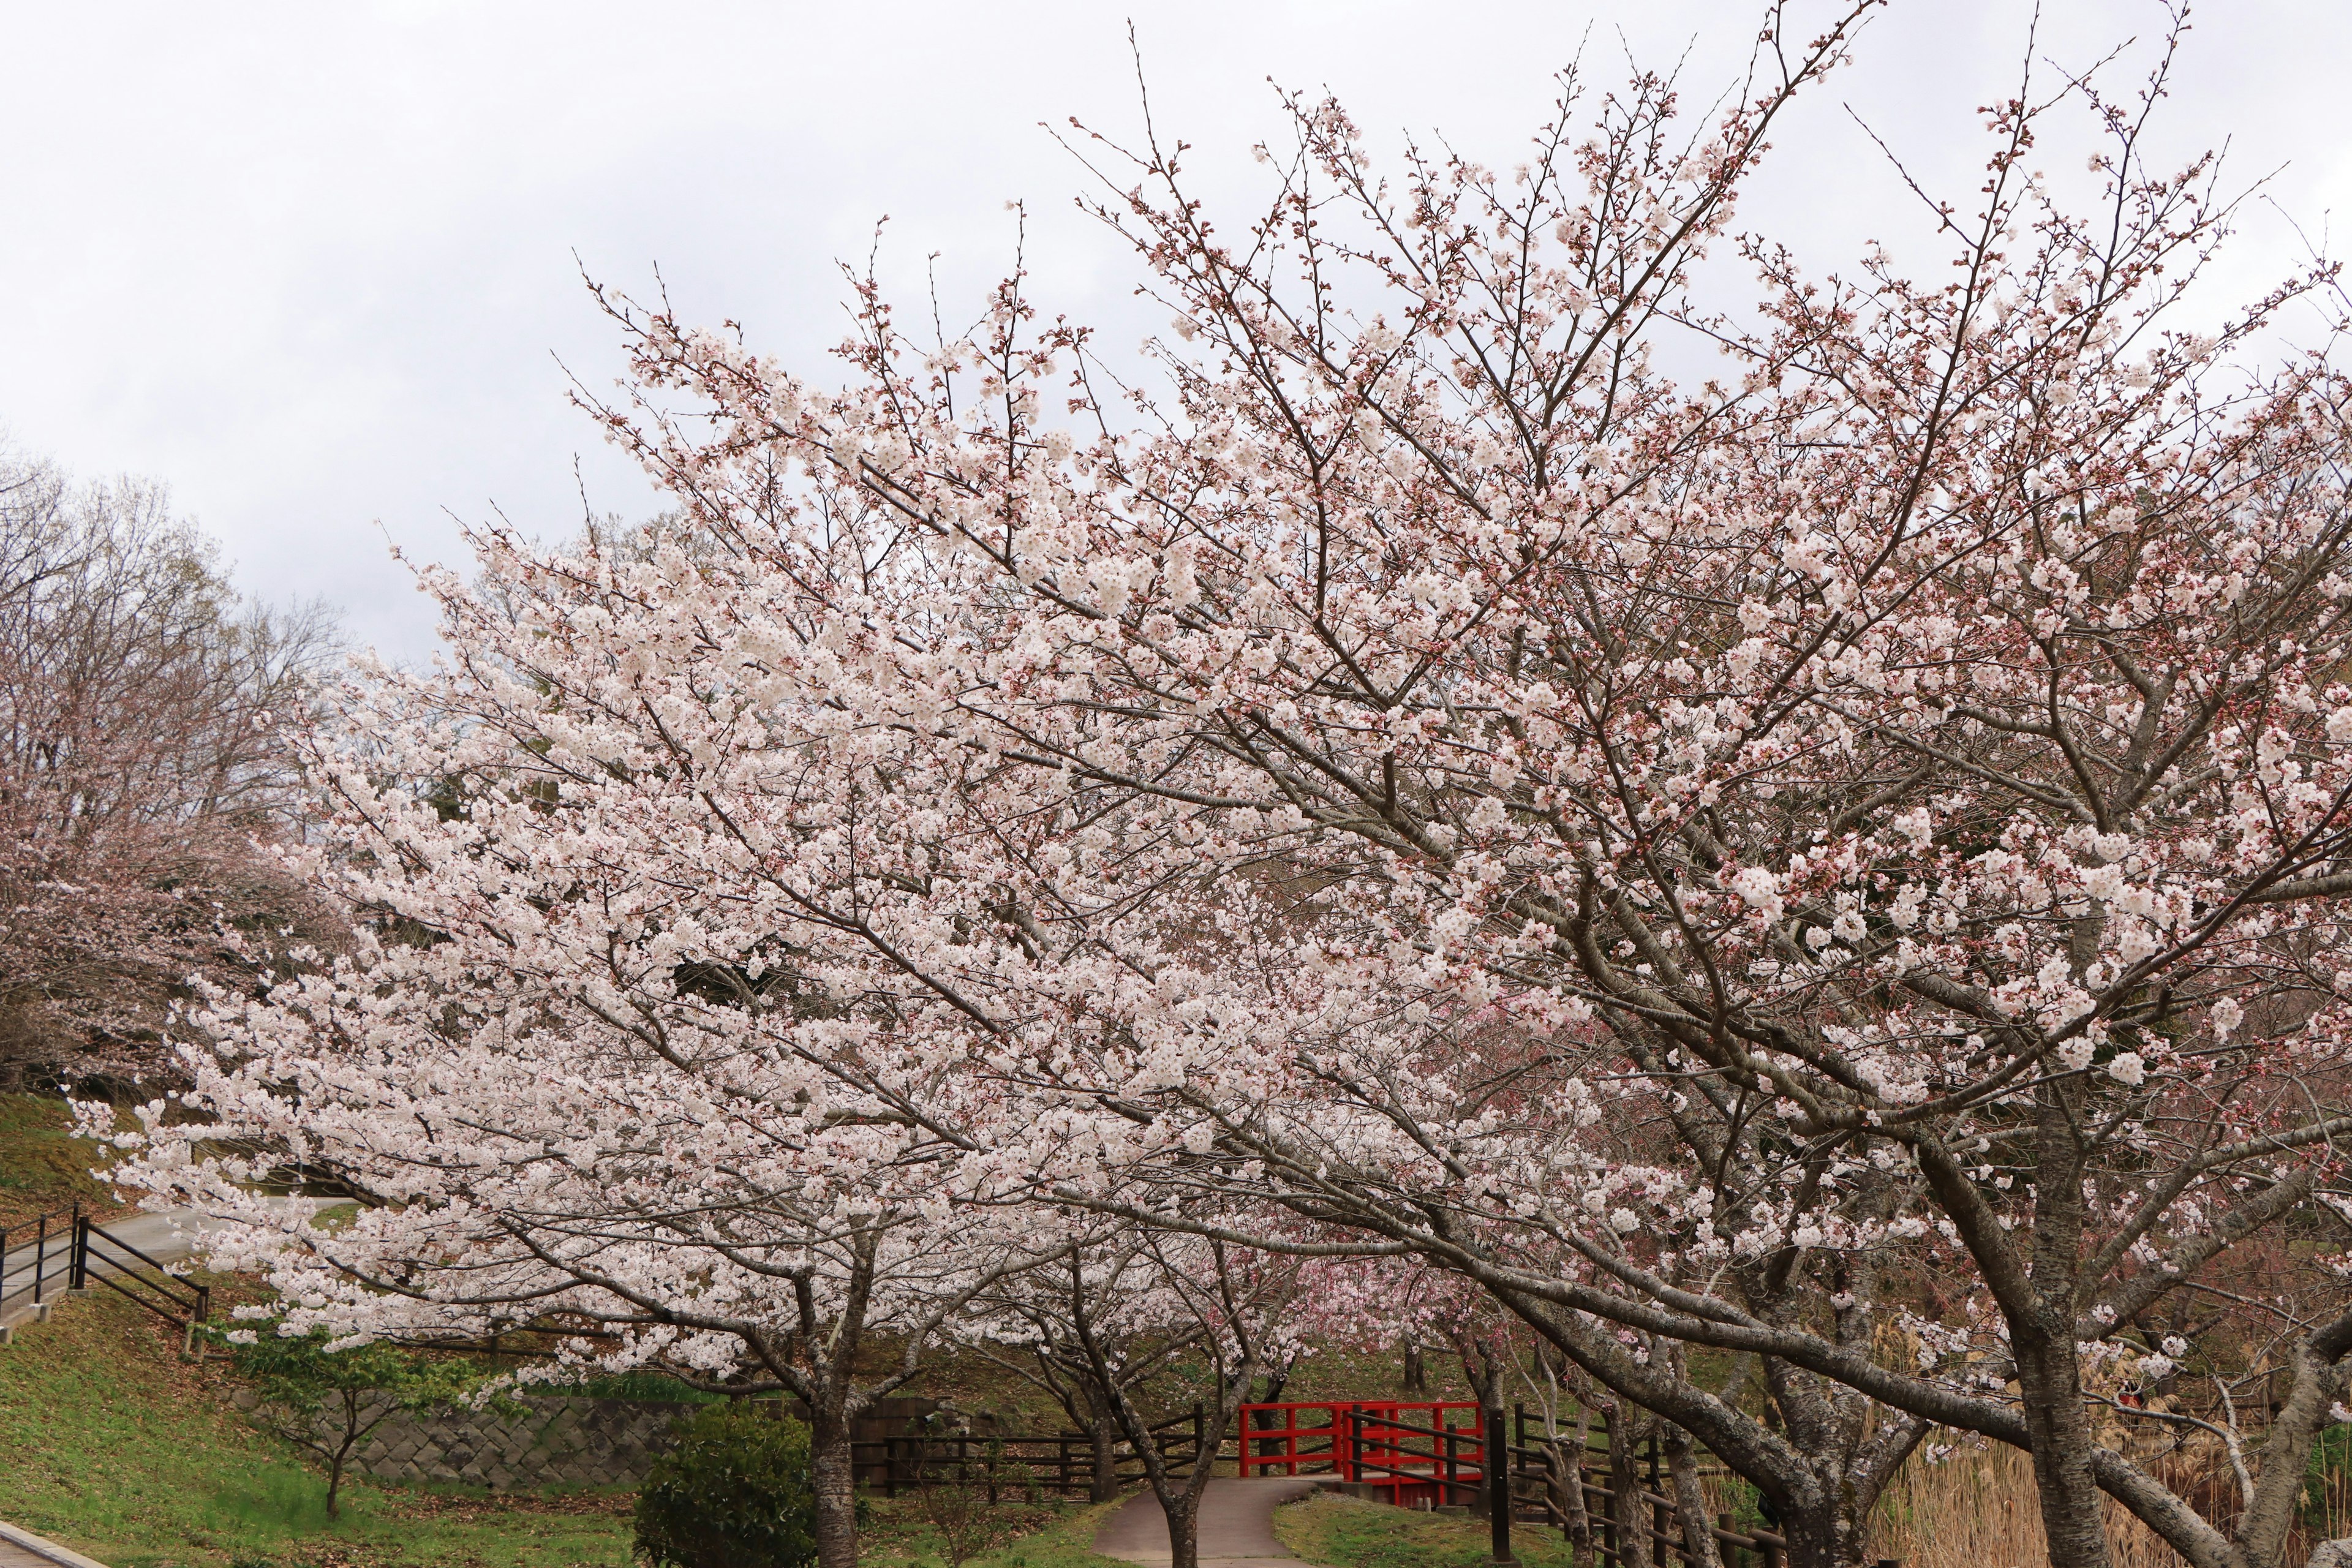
[0,451,334,1086]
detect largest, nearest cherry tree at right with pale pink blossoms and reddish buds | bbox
[555,6,2352,1566]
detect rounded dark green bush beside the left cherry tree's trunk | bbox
[638,1401,816,1568]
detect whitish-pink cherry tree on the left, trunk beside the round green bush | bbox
[92,524,1101,1568]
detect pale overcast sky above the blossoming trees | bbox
[0,0,2352,656]
